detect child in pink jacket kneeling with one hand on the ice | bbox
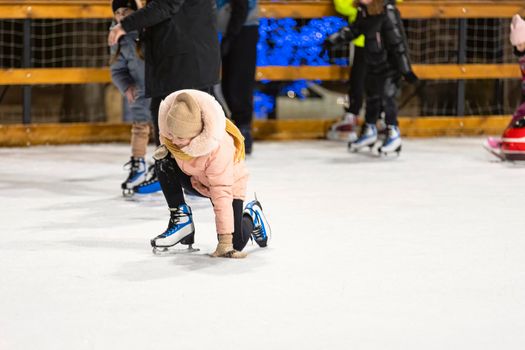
[151,90,270,258]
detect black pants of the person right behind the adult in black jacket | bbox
[221,26,259,127]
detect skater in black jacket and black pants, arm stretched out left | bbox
[327,0,418,154]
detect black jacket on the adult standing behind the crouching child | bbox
[121,0,220,97]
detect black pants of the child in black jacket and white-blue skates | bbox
[365,71,400,125]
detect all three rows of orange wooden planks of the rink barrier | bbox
[0,0,525,146]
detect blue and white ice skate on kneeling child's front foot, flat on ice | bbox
[151,204,199,255]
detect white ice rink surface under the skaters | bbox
[0,138,525,350]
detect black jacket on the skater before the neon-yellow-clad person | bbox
[342,3,412,75]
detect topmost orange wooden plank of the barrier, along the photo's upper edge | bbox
[0,0,525,19]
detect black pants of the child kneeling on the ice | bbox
[155,154,253,251]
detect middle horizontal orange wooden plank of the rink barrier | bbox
[0,64,521,85]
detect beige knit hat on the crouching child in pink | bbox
[166,92,202,139]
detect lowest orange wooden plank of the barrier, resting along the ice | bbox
[0,116,510,147]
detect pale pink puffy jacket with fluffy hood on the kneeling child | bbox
[159,90,248,234]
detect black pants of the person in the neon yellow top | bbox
[347,46,366,115]
